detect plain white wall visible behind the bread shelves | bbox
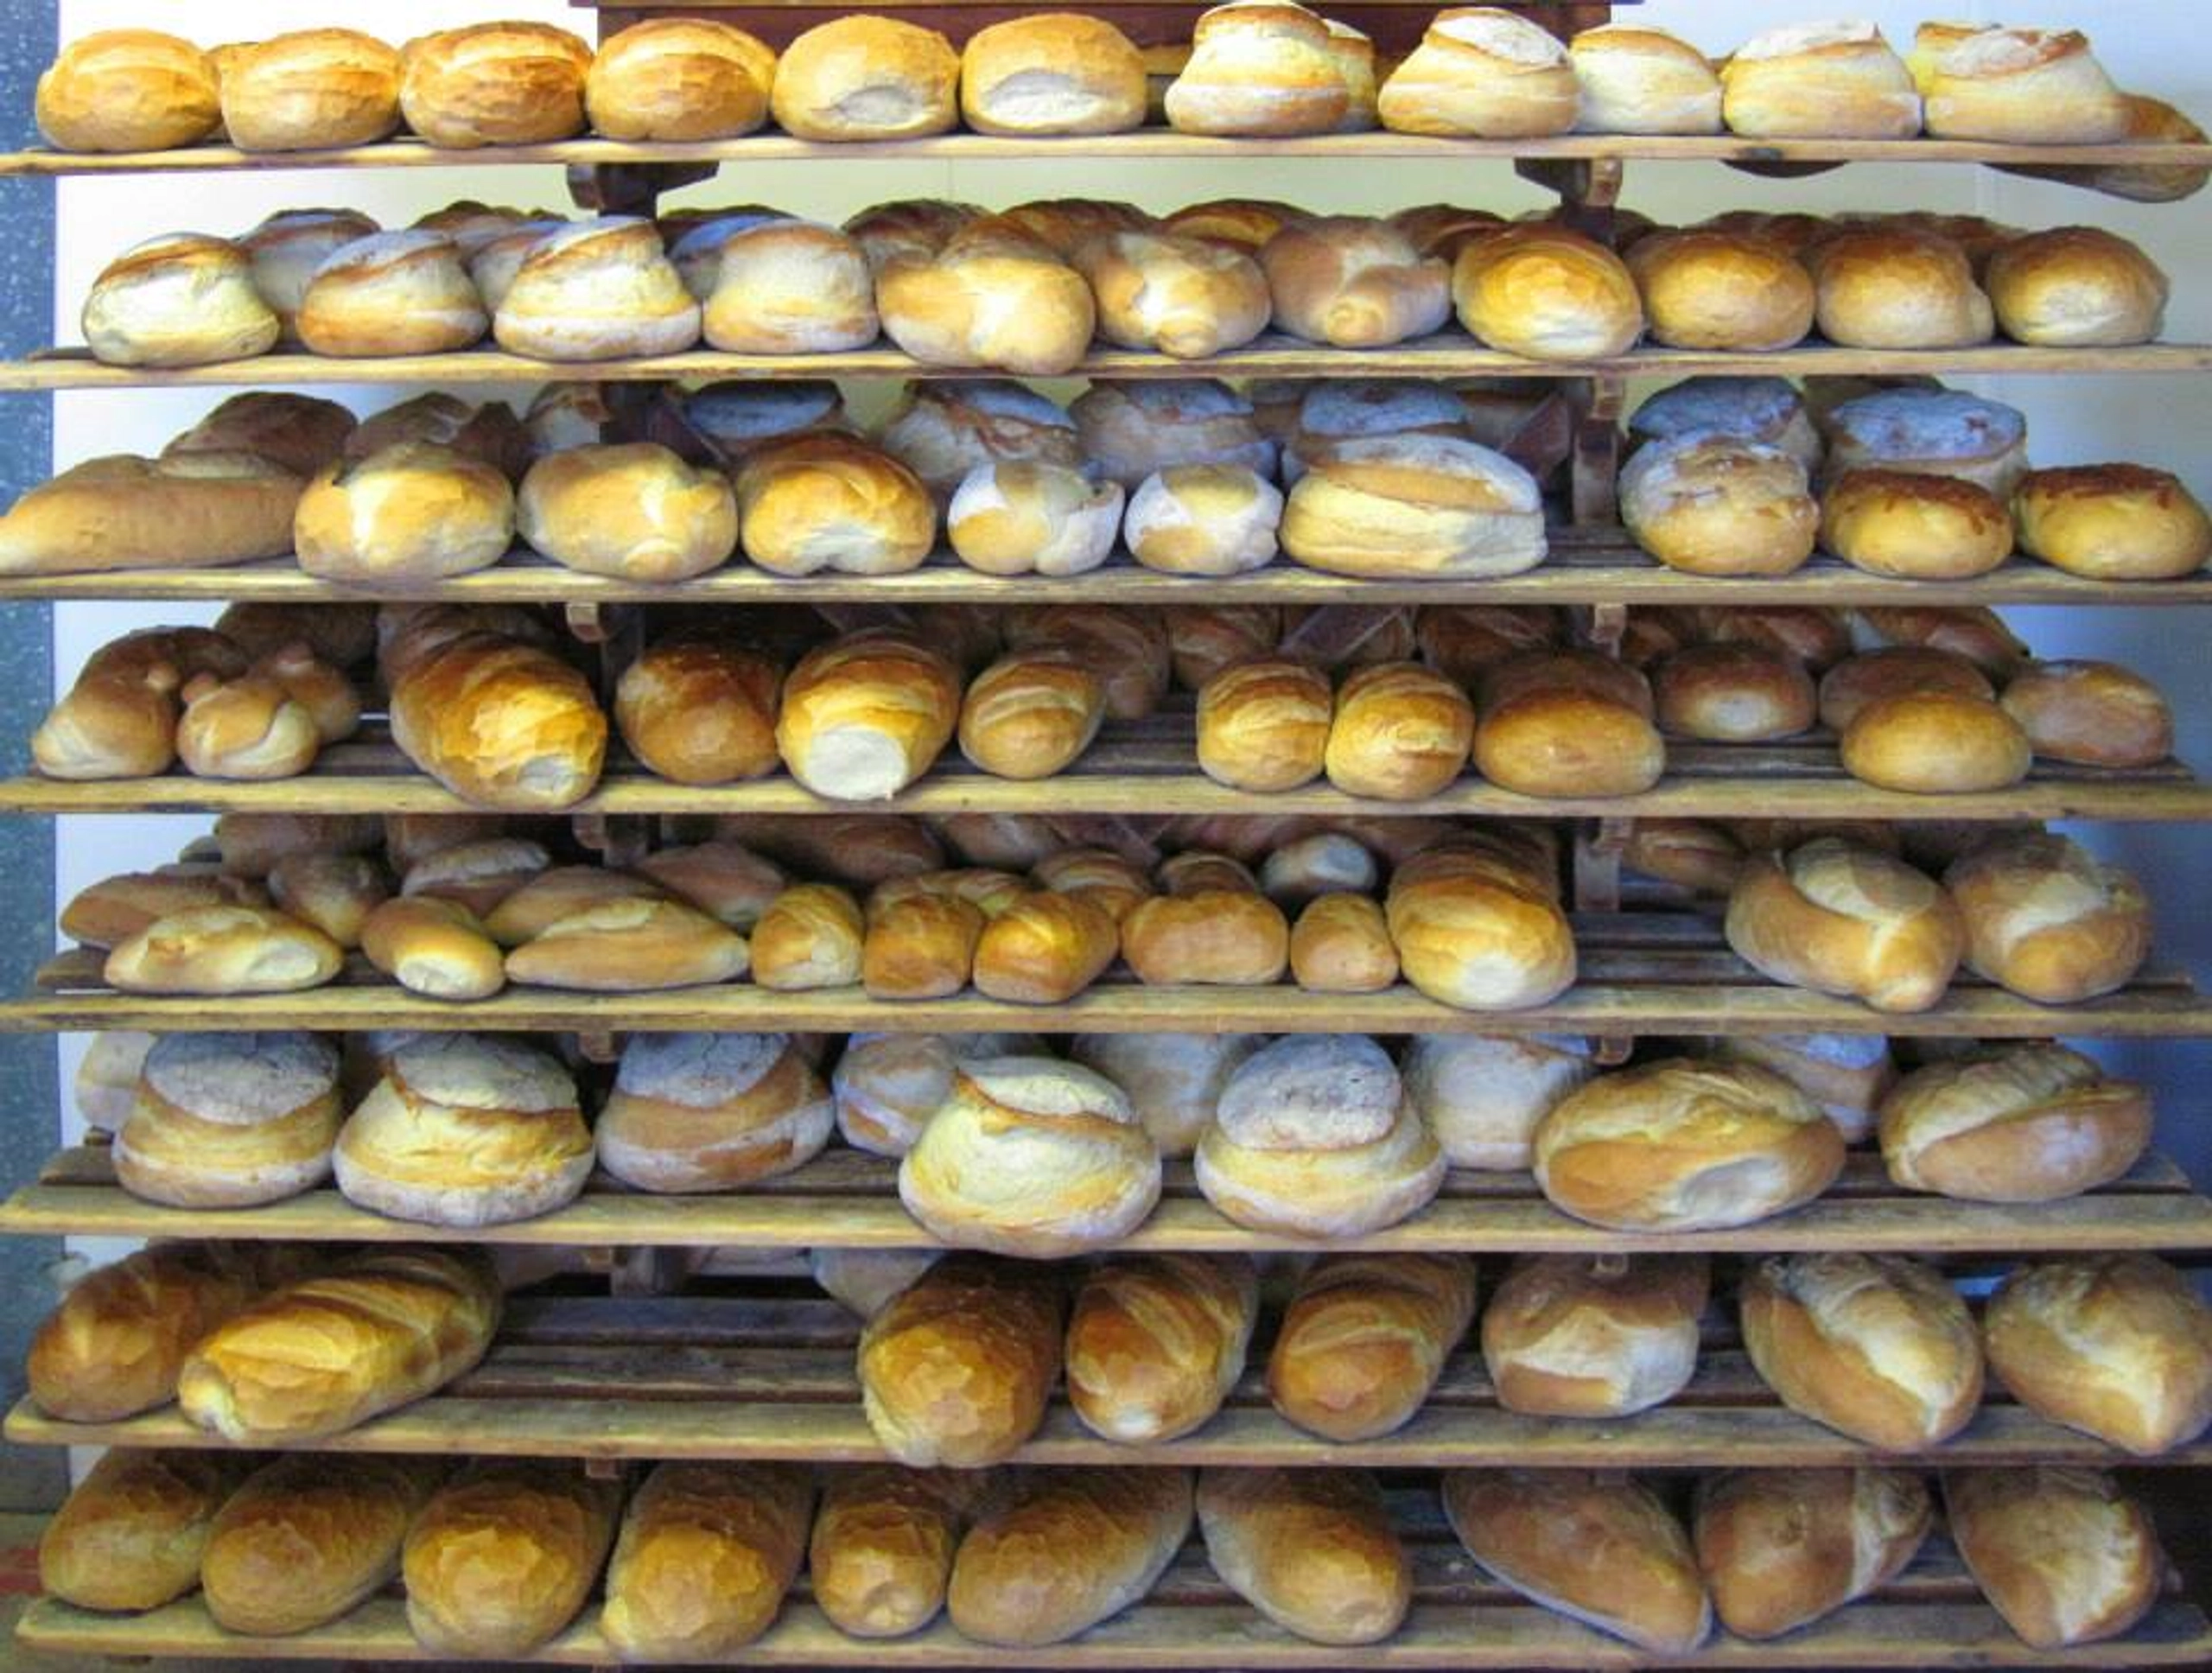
[42,0,2212,1175]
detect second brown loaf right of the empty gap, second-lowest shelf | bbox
[1066,1255,1259,1445]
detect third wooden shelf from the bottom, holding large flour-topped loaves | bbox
[0,1147,2212,1255]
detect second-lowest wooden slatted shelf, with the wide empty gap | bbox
[7,1297,2212,1469]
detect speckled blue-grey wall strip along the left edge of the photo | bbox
[0,0,64,1509]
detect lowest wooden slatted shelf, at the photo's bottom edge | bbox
[16,1598,2212,1673]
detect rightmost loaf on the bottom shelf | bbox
[1942,1465,2165,1651]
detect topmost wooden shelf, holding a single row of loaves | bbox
[0,128,2212,177]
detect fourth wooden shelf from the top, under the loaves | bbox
[13,706,2212,821]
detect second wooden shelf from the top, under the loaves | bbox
[0,332,2212,391]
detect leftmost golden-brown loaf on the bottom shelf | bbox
[38,1447,252,1611]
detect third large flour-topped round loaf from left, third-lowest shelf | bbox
[593,1034,836,1191]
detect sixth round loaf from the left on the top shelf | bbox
[960,11,1146,135]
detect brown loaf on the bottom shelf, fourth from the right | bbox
[1199,1469,1414,1644]
